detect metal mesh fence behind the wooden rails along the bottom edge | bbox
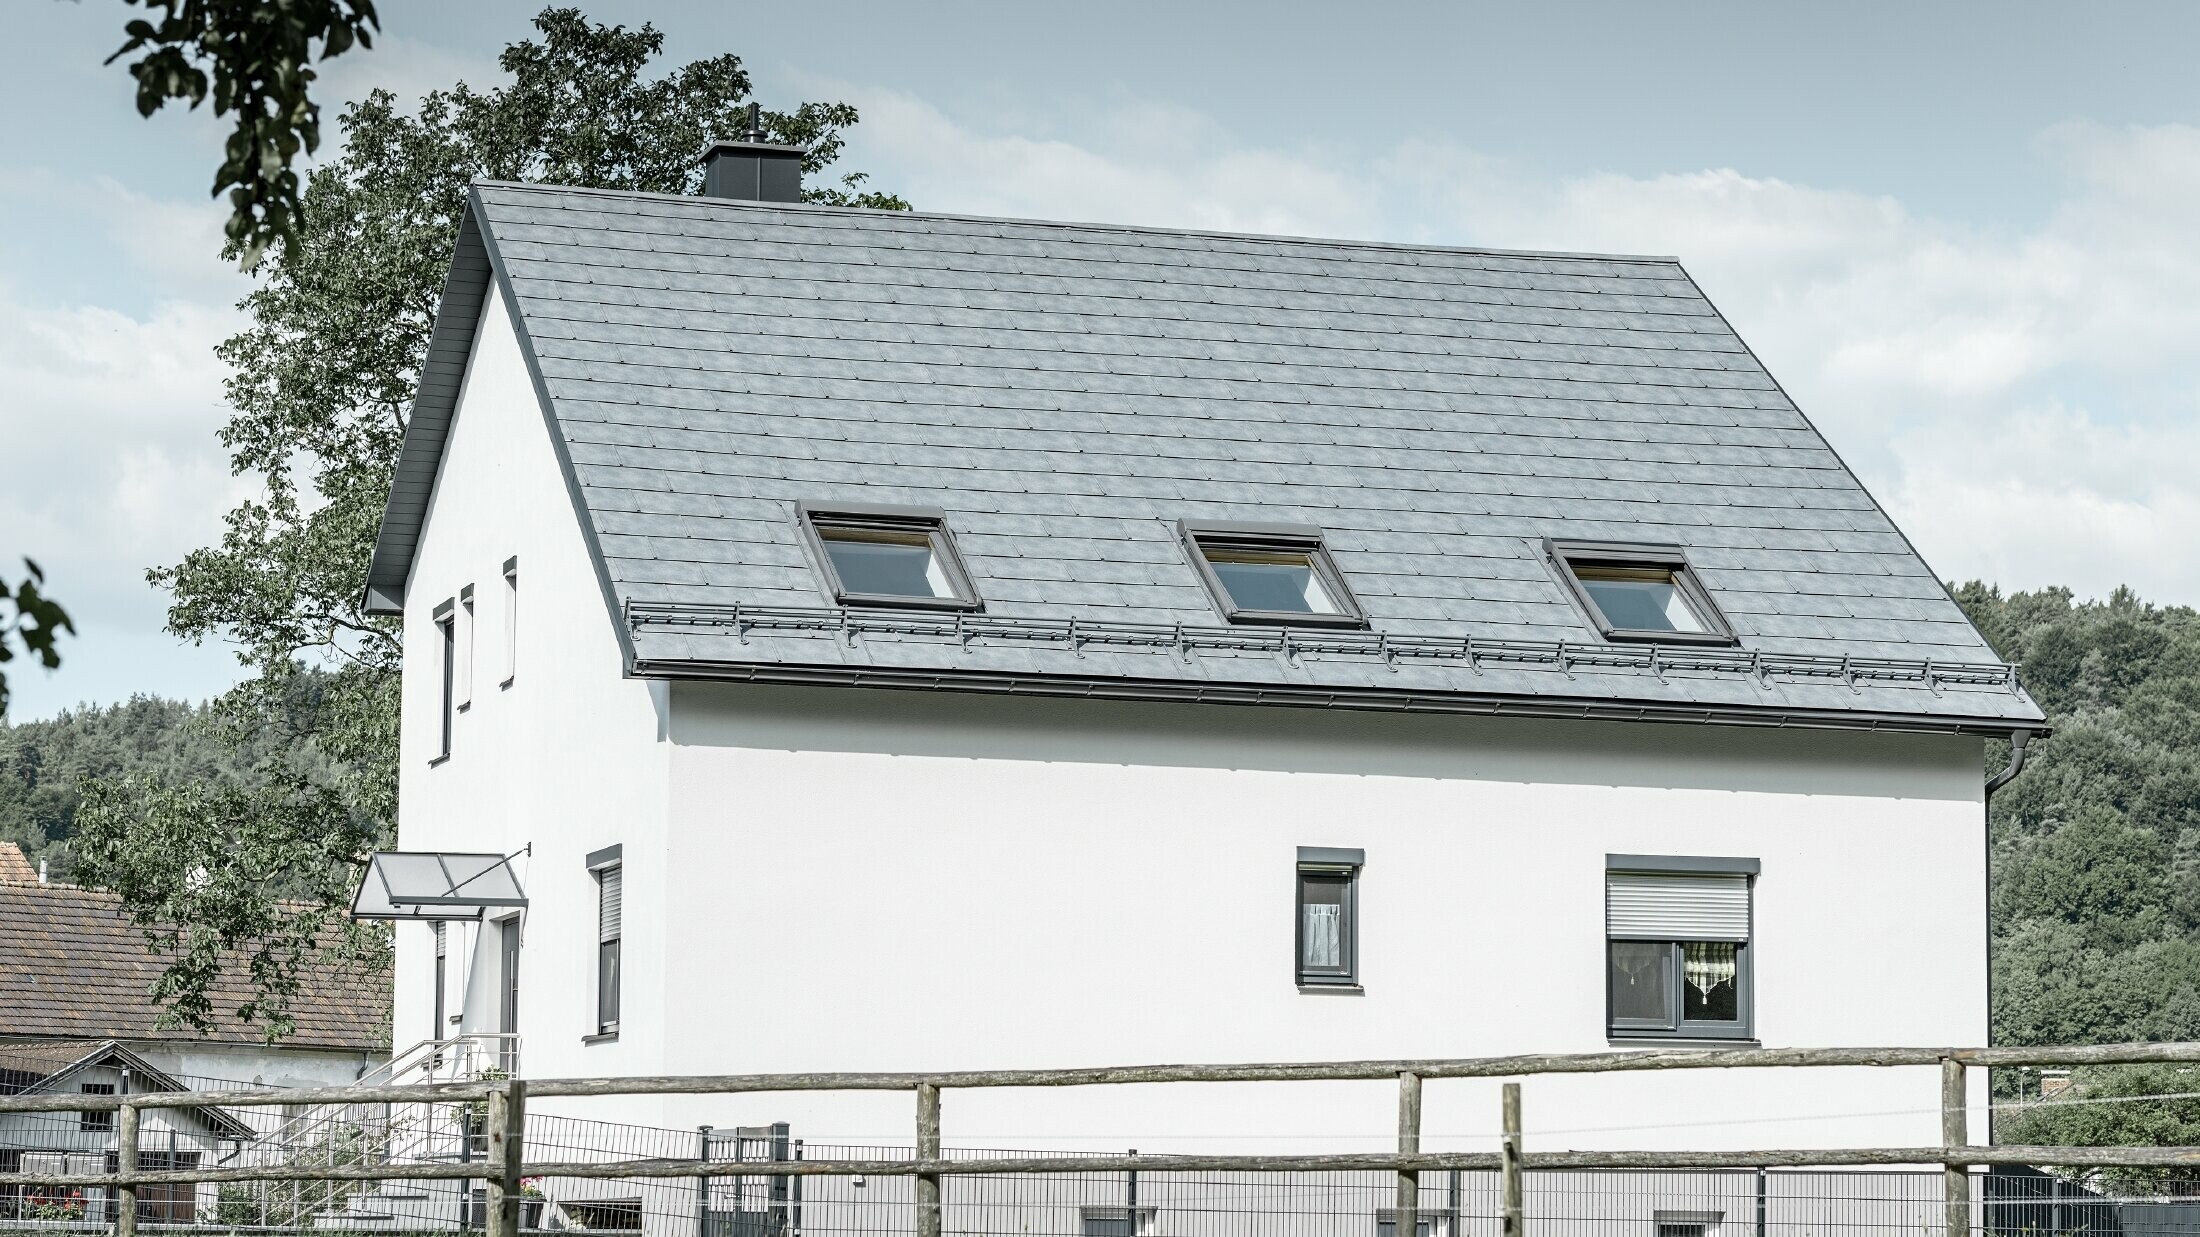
[0,1047,2200,1237]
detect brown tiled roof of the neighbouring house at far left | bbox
[0,883,389,1052]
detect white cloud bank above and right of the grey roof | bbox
[827,81,2200,603]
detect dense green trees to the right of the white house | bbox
[1958,583,2200,1162]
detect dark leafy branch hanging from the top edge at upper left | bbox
[108,0,381,269]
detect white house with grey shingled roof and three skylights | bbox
[361,134,2042,1151]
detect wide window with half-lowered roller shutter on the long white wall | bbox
[1604,854,1758,1039]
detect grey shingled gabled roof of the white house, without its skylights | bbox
[370,183,2039,731]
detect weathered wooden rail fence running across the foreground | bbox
[0,1043,2200,1237]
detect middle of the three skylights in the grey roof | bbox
[1181,519,1366,627]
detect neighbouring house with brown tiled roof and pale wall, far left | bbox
[0,843,389,1087]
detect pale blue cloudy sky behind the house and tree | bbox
[0,0,2200,720]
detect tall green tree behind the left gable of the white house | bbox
[75,9,906,1037]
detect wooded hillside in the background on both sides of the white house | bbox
[0,583,2200,1043]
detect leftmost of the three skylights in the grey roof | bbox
[801,504,979,610]
